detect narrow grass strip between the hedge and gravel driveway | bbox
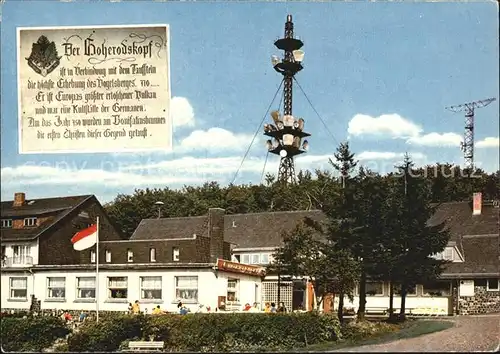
[300,320,454,352]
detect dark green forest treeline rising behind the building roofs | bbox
[106,165,500,236]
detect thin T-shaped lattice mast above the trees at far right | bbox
[446,98,496,172]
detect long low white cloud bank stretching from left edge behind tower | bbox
[0,155,328,197]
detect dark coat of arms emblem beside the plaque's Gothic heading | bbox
[26,36,61,77]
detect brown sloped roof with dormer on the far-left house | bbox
[0,195,94,241]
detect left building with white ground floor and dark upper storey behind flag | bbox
[1,193,263,311]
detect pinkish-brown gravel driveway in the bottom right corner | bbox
[335,314,500,352]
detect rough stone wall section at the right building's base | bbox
[459,286,500,315]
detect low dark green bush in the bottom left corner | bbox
[1,317,70,352]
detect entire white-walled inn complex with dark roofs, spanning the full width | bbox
[1,194,500,315]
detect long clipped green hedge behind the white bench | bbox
[68,312,340,352]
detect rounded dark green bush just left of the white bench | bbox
[68,315,145,352]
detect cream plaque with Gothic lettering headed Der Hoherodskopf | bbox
[17,25,172,154]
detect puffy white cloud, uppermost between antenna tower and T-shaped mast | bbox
[347,114,422,138]
